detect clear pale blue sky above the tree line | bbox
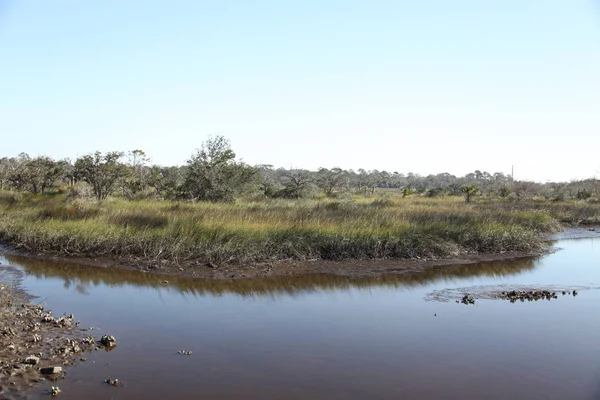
[0,0,600,182]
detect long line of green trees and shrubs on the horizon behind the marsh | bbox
[0,136,599,202]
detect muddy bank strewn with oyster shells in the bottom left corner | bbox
[0,268,110,399]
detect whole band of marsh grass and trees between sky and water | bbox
[0,136,600,264]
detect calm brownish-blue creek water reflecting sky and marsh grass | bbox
[0,239,600,400]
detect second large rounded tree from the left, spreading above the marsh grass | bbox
[73,151,127,200]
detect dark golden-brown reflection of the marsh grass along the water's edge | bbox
[4,255,537,297]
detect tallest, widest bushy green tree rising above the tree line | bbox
[182,136,258,202]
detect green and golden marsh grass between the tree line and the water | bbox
[0,193,600,264]
